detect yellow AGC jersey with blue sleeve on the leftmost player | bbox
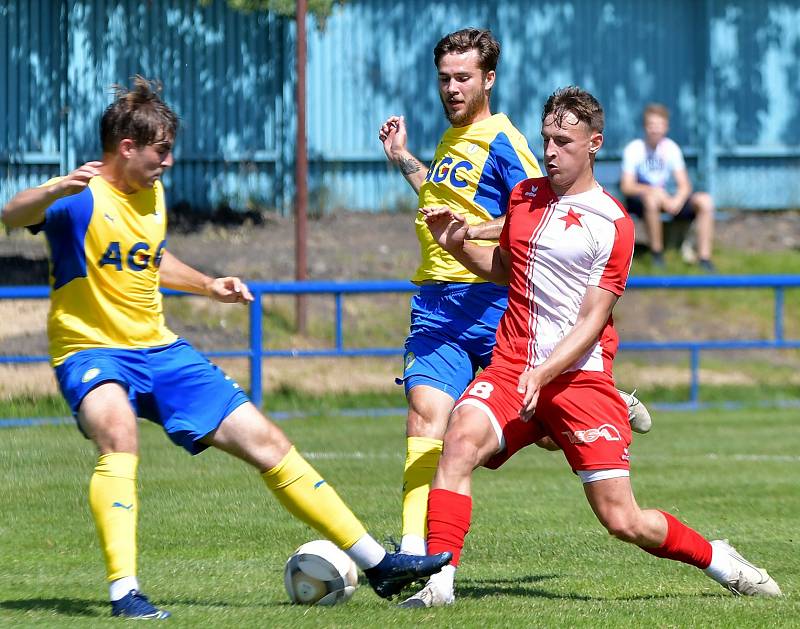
[32,177,177,366]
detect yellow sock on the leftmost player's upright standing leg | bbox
[89,452,139,581]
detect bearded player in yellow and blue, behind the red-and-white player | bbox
[378,28,650,555]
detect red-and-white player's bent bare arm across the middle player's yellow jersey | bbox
[420,207,510,284]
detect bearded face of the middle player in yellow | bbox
[438,50,494,127]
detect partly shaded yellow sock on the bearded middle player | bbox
[403,437,442,539]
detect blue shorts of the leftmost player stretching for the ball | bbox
[56,339,249,454]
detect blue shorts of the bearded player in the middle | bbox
[402,282,508,400]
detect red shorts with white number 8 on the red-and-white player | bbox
[456,364,631,472]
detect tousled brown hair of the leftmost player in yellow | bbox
[100,74,179,153]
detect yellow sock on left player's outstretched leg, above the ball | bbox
[261,446,367,549]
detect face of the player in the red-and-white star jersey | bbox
[542,112,603,194]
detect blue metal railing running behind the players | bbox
[0,275,800,408]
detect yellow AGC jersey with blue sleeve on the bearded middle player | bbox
[412,114,542,283]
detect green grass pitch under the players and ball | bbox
[0,410,800,628]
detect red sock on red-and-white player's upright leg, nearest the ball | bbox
[428,489,472,566]
